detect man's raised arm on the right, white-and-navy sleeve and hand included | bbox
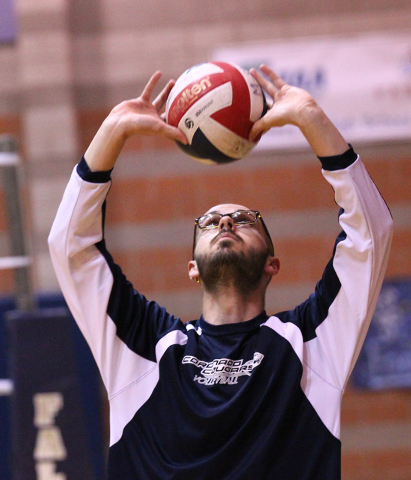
[250,65,393,400]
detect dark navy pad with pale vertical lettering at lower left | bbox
[7,309,102,480]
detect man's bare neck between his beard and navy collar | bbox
[203,286,265,325]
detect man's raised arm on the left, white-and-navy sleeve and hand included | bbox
[49,72,186,395]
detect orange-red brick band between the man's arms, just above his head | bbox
[108,162,334,226]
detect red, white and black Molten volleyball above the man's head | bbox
[166,62,267,165]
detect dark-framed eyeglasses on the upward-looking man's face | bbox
[193,210,274,258]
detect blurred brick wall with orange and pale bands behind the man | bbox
[0,0,411,480]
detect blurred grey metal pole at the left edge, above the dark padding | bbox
[0,135,35,311]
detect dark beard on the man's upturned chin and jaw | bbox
[195,241,270,296]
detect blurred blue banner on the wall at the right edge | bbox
[352,279,411,389]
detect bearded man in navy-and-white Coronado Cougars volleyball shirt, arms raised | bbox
[49,66,392,480]
